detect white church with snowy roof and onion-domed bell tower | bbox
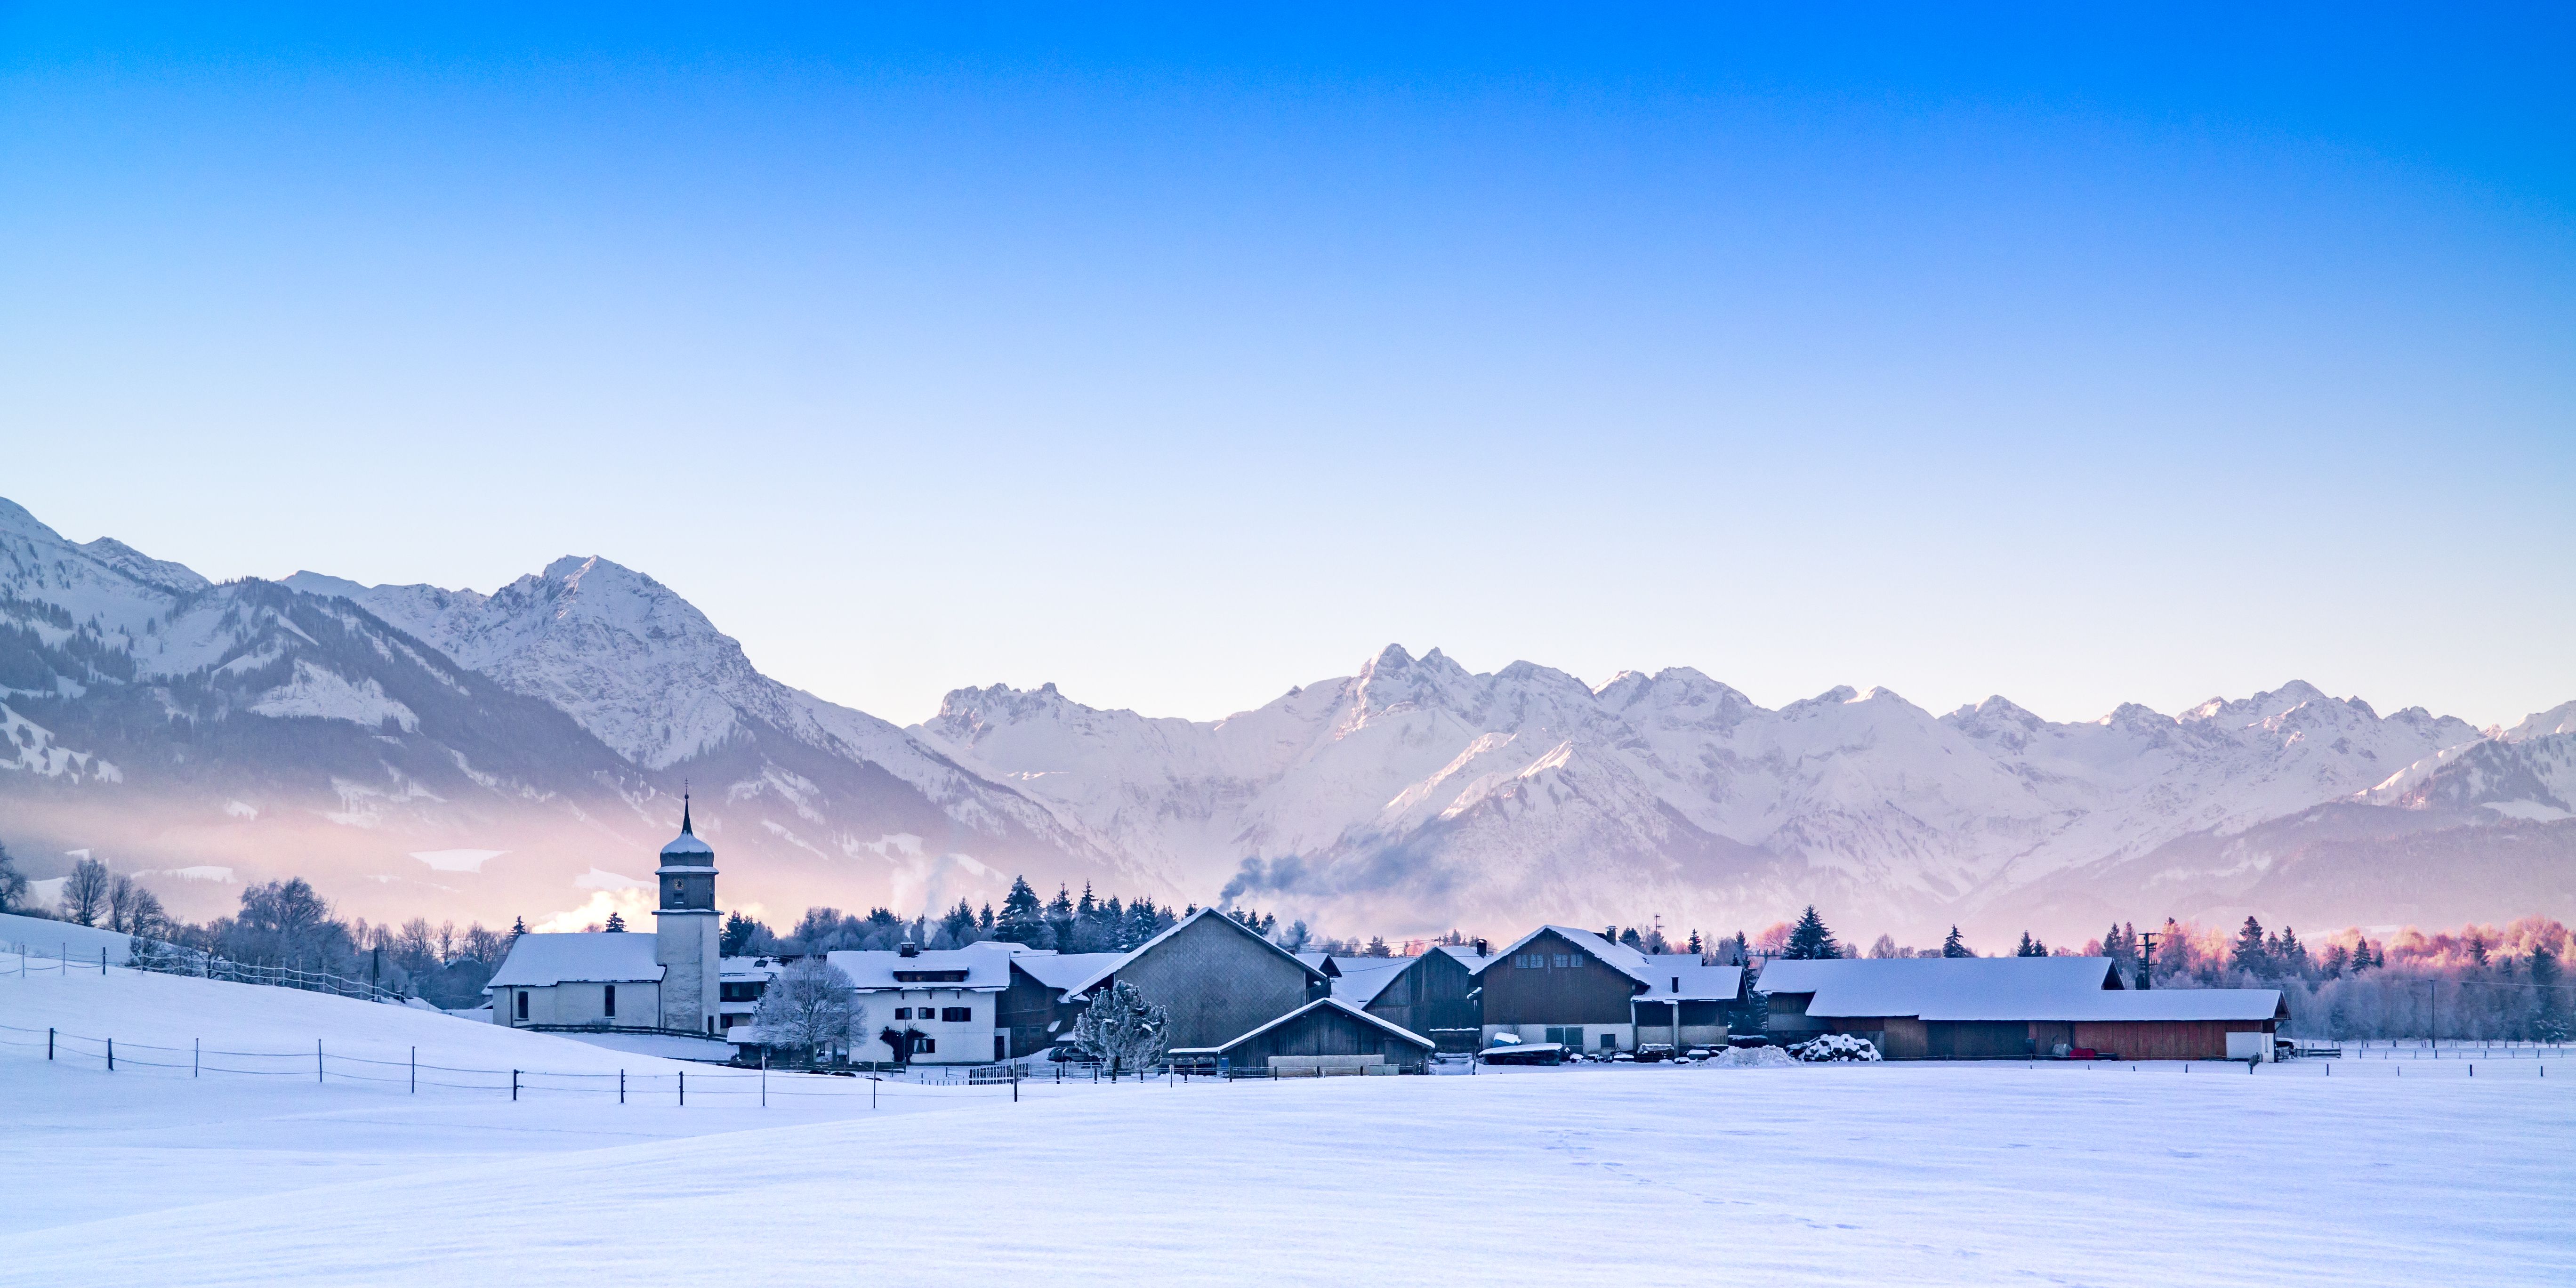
[484,796,724,1038]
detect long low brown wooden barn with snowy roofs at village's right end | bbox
[1754,958,2287,1059]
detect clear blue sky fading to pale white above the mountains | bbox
[0,5,2576,724]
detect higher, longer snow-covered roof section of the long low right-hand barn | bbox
[1754,958,2120,1020]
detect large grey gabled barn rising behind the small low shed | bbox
[1059,907,1329,1046]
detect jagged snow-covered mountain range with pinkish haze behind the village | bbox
[0,502,2576,938]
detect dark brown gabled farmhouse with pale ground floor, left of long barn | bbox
[1471,925,1741,1054]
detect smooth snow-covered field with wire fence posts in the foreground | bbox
[0,953,2576,1288]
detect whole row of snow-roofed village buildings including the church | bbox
[484,809,2295,1077]
